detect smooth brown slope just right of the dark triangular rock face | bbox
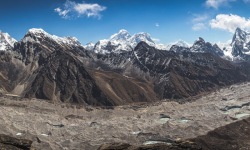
[91,70,160,105]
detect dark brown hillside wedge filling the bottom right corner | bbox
[192,118,250,150]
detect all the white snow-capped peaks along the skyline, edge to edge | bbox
[0,28,250,61]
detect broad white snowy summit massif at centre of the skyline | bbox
[88,29,164,54]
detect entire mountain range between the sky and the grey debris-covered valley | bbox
[0,28,250,106]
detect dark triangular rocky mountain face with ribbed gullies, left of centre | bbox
[24,50,114,106]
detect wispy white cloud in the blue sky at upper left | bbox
[54,0,106,19]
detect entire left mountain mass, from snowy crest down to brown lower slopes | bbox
[1,29,162,106]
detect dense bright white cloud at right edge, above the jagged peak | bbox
[209,14,250,33]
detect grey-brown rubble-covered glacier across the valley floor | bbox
[0,83,250,150]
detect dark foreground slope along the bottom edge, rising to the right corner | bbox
[98,118,250,150]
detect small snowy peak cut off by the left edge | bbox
[0,31,17,51]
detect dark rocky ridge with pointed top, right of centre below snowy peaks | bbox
[94,42,249,99]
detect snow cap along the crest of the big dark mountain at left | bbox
[21,28,81,46]
